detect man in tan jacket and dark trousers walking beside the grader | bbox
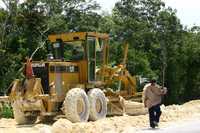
[143,79,167,128]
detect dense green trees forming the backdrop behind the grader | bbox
[0,0,200,104]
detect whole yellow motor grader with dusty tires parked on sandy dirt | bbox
[2,32,141,124]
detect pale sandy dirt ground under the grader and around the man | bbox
[0,100,200,133]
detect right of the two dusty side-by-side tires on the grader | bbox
[88,88,107,121]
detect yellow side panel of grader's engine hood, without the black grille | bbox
[48,62,83,97]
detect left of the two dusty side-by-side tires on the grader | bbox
[63,88,90,122]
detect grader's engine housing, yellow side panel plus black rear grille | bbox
[32,62,80,96]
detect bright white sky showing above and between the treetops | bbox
[96,0,200,27]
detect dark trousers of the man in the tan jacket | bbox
[149,104,162,128]
